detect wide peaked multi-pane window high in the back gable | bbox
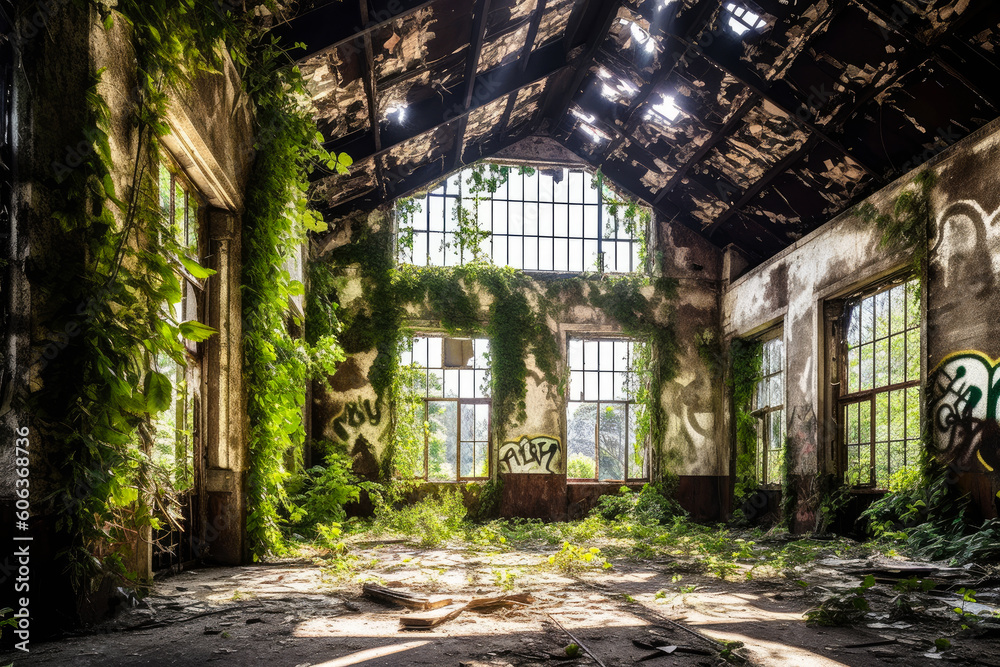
[397,165,649,273]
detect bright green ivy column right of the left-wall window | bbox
[241,32,345,560]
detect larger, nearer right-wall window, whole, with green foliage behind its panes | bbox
[840,280,920,489]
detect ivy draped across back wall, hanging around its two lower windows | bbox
[307,223,678,481]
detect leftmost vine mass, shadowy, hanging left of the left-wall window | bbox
[25,0,250,593]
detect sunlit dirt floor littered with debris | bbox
[0,540,1000,667]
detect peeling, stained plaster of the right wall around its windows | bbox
[721,117,1000,525]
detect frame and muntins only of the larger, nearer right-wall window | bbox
[835,272,925,492]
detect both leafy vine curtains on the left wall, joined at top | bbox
[27,0,349,590]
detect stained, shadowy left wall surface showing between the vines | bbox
[0,3,252,637]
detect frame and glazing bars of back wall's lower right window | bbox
[565,332,651,484]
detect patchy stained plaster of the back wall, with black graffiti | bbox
[311,201,729,518]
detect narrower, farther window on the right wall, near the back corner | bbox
[753,335,785,486]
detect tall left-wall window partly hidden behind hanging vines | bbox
[153,163,204,489]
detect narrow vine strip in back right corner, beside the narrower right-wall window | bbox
[729,338,760,499]
